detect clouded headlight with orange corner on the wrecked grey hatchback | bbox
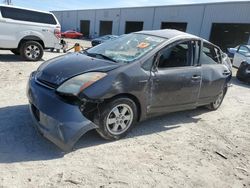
[57,72,107,96]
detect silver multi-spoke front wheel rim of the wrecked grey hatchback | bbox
[106,104,134,135]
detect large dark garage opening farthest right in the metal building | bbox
[210,23,250,51]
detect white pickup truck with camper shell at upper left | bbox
[0,5,61,61]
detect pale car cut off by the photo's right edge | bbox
[233,45,250,83]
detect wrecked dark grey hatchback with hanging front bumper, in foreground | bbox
[27,29,231,151]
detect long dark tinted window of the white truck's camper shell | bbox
[0,7,57,25]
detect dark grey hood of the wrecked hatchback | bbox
[36,53,120,86]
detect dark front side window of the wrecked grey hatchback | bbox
[158,42,190,68]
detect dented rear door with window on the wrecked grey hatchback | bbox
[198,42,231,105]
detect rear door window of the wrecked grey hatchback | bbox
[200,42,221,64]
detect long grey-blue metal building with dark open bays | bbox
[52,1,250,49]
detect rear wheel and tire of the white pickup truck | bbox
[20,41,43,61]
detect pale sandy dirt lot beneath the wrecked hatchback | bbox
[0,39,250,188]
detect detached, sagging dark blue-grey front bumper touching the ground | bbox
[27,75,97,151]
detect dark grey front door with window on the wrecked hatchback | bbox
[149,41,201,113]
